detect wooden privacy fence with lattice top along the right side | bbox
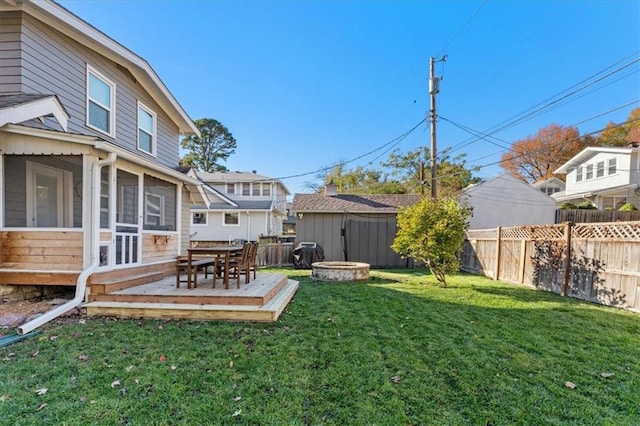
[461,222,640,310]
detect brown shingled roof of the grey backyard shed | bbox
[291,194,421,213]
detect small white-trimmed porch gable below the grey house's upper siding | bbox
[0,93,69,131]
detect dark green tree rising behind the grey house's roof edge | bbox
[180,118,237,172]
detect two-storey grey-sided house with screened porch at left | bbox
[0,0,200,285]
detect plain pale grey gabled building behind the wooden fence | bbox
[461,174,556,229]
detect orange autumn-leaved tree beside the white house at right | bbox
[500,123,584,183]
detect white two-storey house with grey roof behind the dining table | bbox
[188,170,290,243]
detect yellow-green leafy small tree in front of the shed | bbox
[391,198,471,287]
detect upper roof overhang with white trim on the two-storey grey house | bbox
[0,0,200,135]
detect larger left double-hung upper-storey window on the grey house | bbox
[87,66,116,137]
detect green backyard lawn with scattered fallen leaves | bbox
[0,270,640,425]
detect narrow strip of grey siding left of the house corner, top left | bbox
[0,12,21,93]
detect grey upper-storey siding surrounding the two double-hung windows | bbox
[16,15,179,168]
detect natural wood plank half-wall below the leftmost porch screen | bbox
[0,231,83,271]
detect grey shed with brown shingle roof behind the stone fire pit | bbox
[291,185,421,267]
